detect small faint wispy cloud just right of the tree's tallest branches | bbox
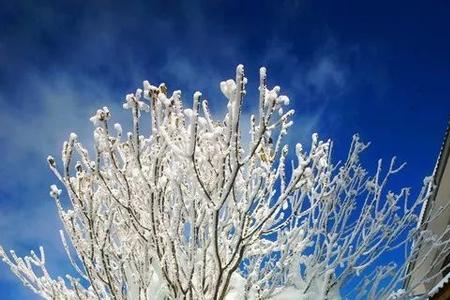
[263,37,353,144]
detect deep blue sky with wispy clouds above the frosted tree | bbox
[0,0,450,299]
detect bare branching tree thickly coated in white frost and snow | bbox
[0,65,449,300]
